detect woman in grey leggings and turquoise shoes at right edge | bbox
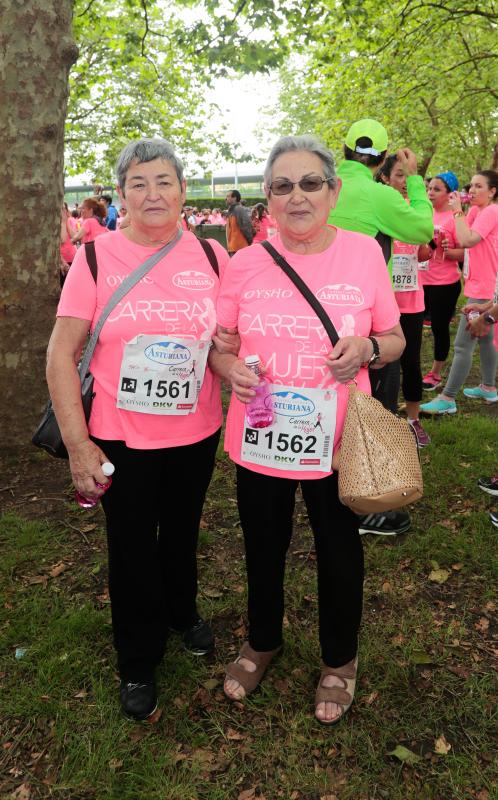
[420,170,498,414]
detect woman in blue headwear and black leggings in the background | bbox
[420,170,464,391]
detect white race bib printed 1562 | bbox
[241,383,337,472]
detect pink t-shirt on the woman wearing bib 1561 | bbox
[57,230,229,450]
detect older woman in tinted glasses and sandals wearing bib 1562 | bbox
[213,136,404,725]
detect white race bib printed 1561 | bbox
[116,334,210,416]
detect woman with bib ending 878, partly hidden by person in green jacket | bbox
[376,155,431,447]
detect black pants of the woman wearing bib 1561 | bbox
[94,431,220,681]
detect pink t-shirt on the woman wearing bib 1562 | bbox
[217,229,399,480]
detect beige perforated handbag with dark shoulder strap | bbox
[261,242,423,514]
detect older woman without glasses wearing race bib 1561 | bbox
[47,139,228,720]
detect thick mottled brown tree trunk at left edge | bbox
[0,0,78,447]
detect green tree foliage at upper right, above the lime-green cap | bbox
[274,0,498,180]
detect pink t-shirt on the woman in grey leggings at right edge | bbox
[465,203,498,300]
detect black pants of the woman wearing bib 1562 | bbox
[237,466,363,667]
